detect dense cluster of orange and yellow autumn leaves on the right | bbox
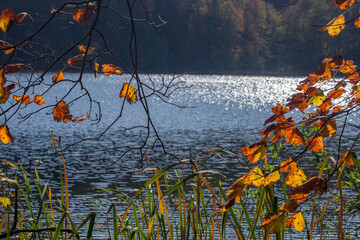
[219,0,360,238]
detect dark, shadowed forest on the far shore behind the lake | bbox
[2,0,360,75]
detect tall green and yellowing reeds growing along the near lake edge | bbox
[0,145,360,240]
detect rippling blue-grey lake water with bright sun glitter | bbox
[0,74,358,238]
